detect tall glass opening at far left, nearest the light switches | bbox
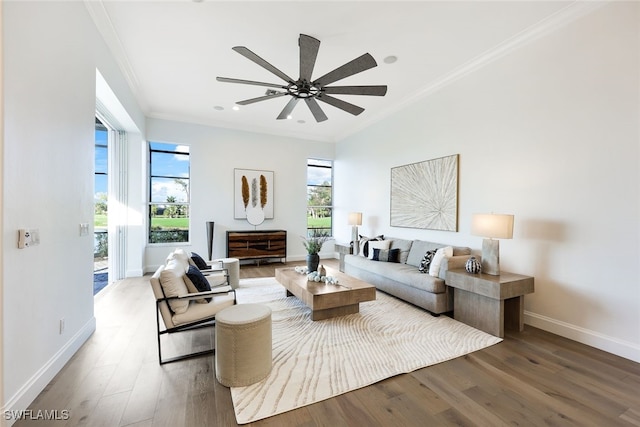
[93,117,109,259]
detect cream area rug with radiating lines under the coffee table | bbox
[231,278,502,424]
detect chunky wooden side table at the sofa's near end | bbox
[446,269,534,338]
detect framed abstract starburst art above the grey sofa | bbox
[390,154,458,231]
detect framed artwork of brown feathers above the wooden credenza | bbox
[233,169,273,225]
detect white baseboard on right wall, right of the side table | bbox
[524,311,640,363]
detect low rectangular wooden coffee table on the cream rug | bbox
[276,268,376,320]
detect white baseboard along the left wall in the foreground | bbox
[1,317,96,426]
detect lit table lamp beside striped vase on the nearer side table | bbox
[471,214,513,276]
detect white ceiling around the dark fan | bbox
[86,0,584,141]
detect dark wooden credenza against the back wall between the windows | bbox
[227,230,287,262]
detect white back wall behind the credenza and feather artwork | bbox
[146,119,335,271]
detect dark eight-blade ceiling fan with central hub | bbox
[216,34,387,122]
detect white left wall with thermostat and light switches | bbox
[2,1,144,421]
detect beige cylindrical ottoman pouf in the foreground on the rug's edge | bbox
[216,304,272,387]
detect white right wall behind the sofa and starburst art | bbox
[335,2,640,361]
